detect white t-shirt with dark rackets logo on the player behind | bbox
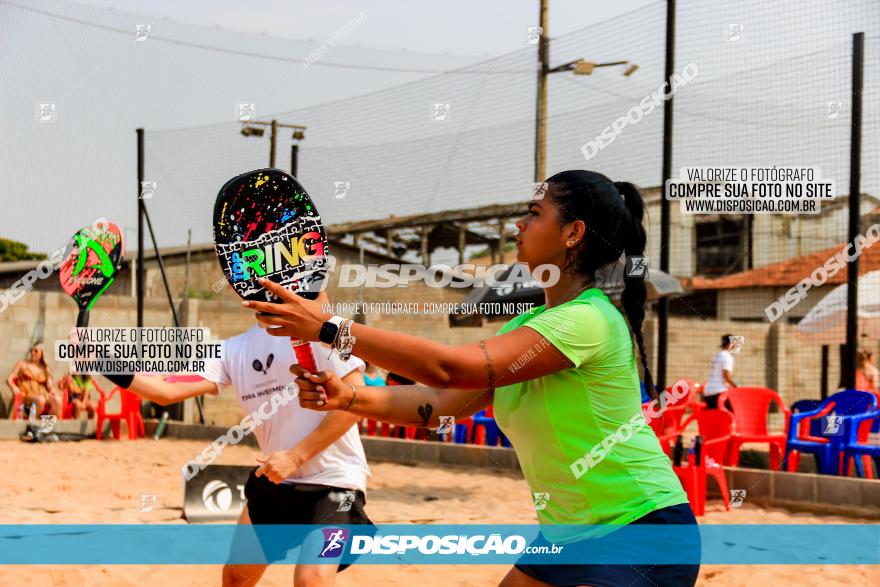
[200,326,370,491]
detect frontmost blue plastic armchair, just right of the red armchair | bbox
[785,389,877,475]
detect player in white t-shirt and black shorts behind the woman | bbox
[102,316,372,587]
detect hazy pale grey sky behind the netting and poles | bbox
[0,0,880,260]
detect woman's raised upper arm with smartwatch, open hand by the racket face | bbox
[244,280,572,389]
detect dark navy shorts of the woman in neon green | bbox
[516,504,700,587]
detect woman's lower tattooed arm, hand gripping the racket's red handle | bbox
[290,364,494,428]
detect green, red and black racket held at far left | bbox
[58,218,124,328]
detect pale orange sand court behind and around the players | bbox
[0,440,880,587]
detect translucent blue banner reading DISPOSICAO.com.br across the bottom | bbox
[0,524,880,565]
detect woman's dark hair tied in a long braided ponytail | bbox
[547,170,657,399]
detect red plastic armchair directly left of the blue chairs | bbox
[718,387,791,471]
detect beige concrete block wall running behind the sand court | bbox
[0,284,864,425]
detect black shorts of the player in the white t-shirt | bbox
[237,469,373,571]
